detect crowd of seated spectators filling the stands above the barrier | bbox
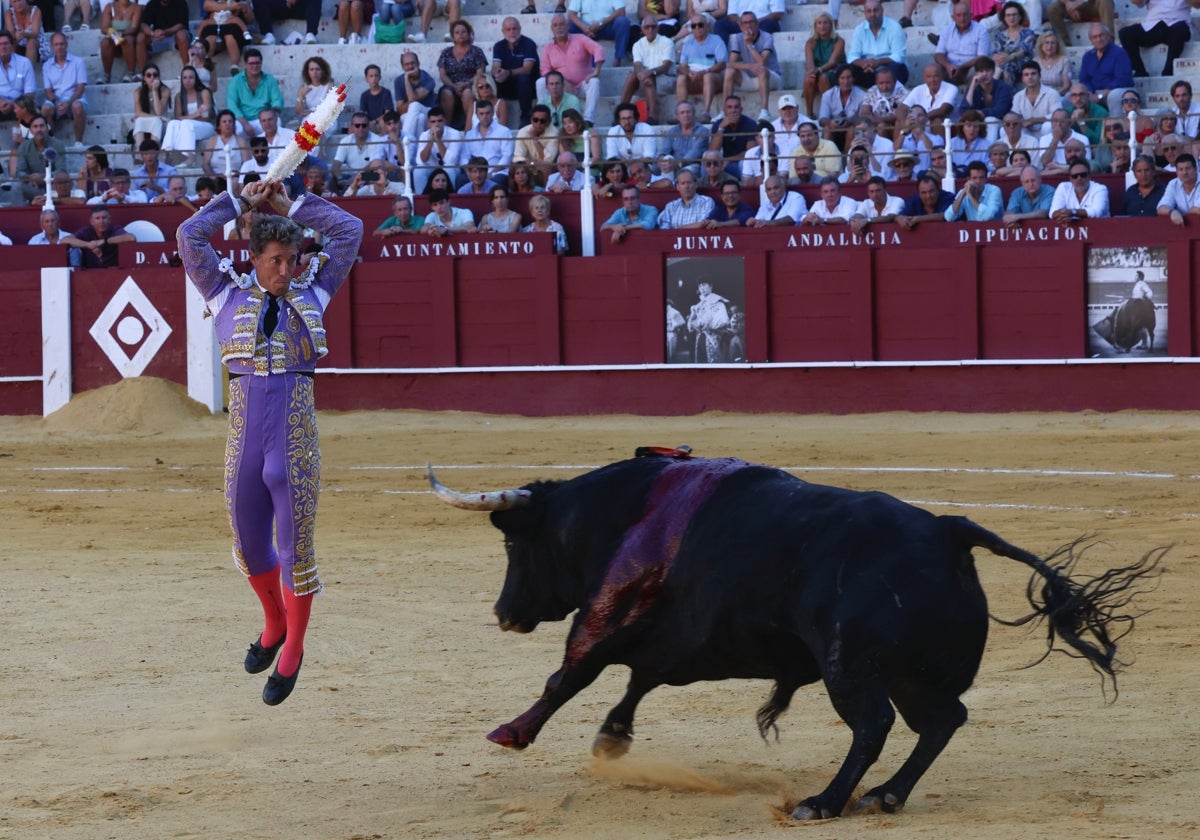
[0,0,1200,252]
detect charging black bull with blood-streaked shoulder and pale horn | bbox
[428,449,1165,820]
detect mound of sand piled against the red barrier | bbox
[43,377,212,436]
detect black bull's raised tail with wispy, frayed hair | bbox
[940,516,1169,700]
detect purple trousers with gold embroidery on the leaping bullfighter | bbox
[226,373,322,595]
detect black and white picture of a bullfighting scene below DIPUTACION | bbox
[1087,247,1168,359]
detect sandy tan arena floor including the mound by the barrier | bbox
[0,380,1200,840]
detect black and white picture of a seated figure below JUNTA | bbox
[666,257,746,365]
